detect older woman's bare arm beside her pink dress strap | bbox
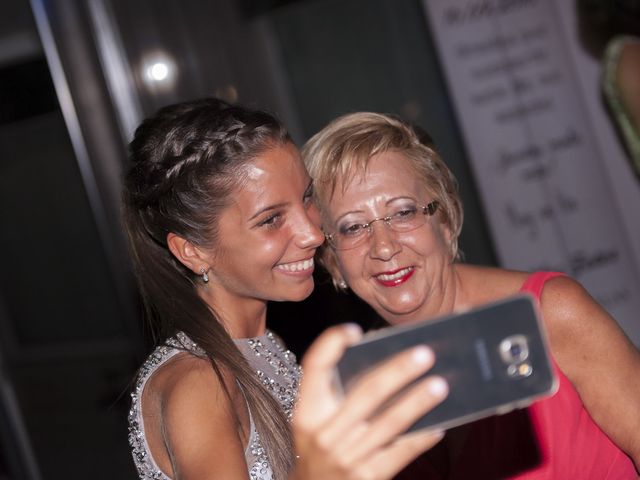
[541,277,640,469]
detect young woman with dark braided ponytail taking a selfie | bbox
[124,99,446,480]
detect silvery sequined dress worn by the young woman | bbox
[129,330,301,480]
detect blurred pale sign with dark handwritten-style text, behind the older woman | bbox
[423,0,640,344]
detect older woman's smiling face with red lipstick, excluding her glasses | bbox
[323,151,452,323]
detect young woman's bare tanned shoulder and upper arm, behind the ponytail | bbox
[161,357,248,480]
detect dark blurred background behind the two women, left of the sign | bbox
[0,0,637,480]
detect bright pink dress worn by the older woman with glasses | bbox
[397,272,638,480]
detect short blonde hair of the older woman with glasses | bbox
[302,112,464,288]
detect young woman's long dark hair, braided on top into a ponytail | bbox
[123,98,293,478]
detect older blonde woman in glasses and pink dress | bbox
[303,113,640,479]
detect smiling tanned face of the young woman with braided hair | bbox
[203,144,324,318]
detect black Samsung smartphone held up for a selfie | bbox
[336,294,558,431]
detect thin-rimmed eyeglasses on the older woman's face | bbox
[325,200,440,250]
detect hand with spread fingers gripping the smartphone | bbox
[289,326,447,480]
